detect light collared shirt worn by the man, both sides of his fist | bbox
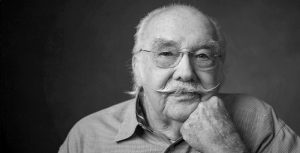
[59,94,300,153]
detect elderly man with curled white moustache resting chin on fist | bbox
[59,5,300,153]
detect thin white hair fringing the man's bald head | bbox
[127,4,226,96]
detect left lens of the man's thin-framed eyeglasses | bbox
[154,49,180,68]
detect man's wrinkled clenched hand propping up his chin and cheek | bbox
[180,96,247,153]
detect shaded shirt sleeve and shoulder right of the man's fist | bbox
[225,95,300,153]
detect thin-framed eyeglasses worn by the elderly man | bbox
[139,49,221,68]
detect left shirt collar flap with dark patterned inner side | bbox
[114,91,148,142]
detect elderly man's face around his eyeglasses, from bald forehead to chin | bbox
[135,10,222,122]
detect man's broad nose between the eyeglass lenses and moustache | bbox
[173,54,197,82]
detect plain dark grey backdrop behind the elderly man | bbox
[0,0,300,153]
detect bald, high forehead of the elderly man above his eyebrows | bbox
[144,7,215,48]
